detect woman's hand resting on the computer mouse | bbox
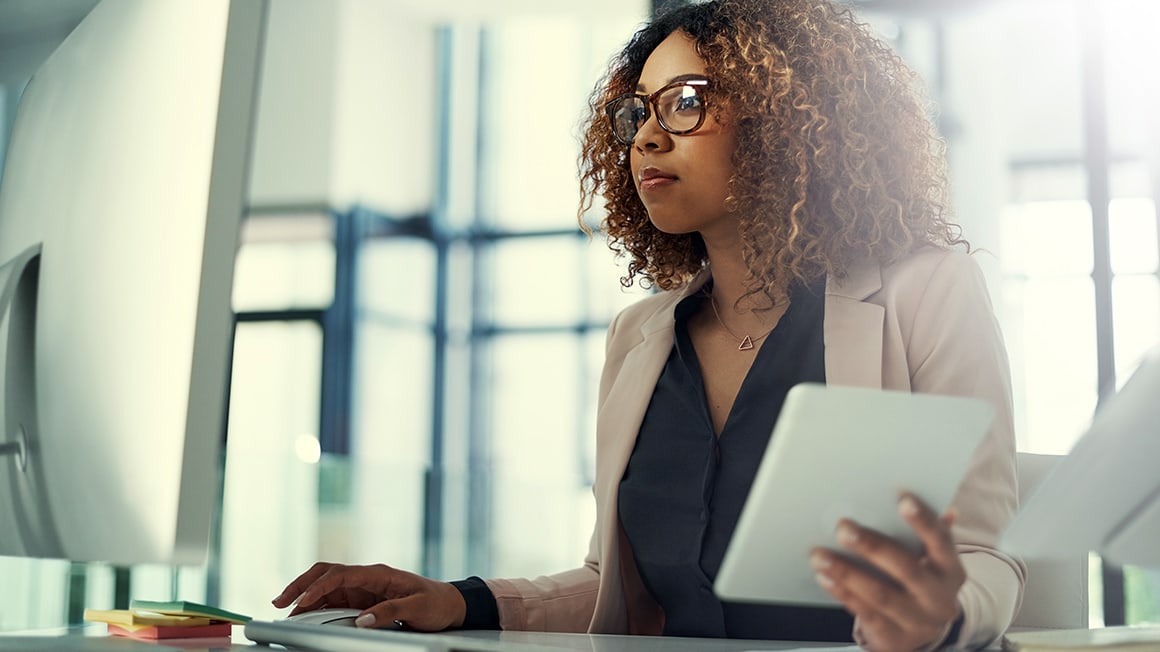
[273,562,467,631]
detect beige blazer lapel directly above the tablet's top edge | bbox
[822,255,885,389]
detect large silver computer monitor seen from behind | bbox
[0,0,267,565]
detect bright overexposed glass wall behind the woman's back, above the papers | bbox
[909,0,1160,624]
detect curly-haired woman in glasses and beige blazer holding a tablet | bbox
[274,0,1024,652]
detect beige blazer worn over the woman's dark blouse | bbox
[487,247,1025,646]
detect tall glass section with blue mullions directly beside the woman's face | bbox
[415,15,640,578]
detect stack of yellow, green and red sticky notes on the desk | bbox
[85,600,249,640]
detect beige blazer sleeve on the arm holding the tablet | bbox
[905,253,1027,649]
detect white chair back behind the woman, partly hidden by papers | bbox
[1012,452,1088,630]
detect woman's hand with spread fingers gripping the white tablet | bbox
[810,494,966,652]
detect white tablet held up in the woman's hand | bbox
[713,384,994,604]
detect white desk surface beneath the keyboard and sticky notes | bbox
[0,625,854,652]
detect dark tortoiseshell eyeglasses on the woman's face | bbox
[604,79,709,145]
